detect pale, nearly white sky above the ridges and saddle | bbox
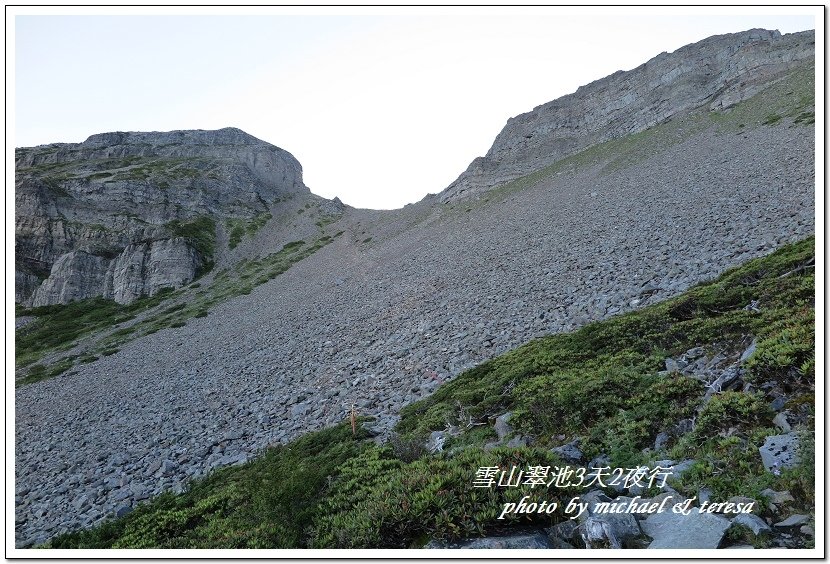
[7,8,821,209]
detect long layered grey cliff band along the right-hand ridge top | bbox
[440,29,815,202]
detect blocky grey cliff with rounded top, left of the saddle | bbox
[15,128,308,306]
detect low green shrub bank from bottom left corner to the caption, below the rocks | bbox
[49,424,572,548]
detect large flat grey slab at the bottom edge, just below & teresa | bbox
[642,510,730,548]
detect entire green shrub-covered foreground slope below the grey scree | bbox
[49,238,815,548]
